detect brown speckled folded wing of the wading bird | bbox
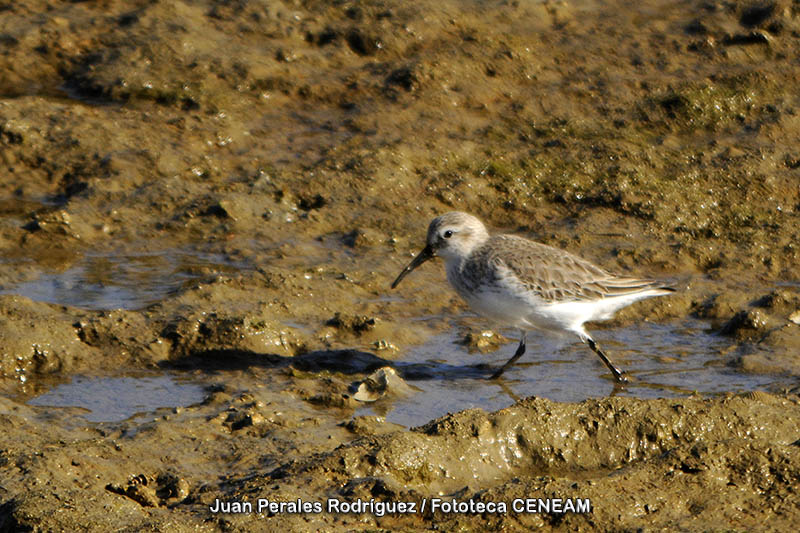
[465,235,663,302]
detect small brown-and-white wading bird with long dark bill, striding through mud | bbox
[392,212,675,382]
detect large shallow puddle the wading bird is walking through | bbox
[357,321,780,427]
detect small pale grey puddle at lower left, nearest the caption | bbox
[28,375,206,422]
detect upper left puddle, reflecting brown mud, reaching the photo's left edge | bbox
[0,250,246,310]
